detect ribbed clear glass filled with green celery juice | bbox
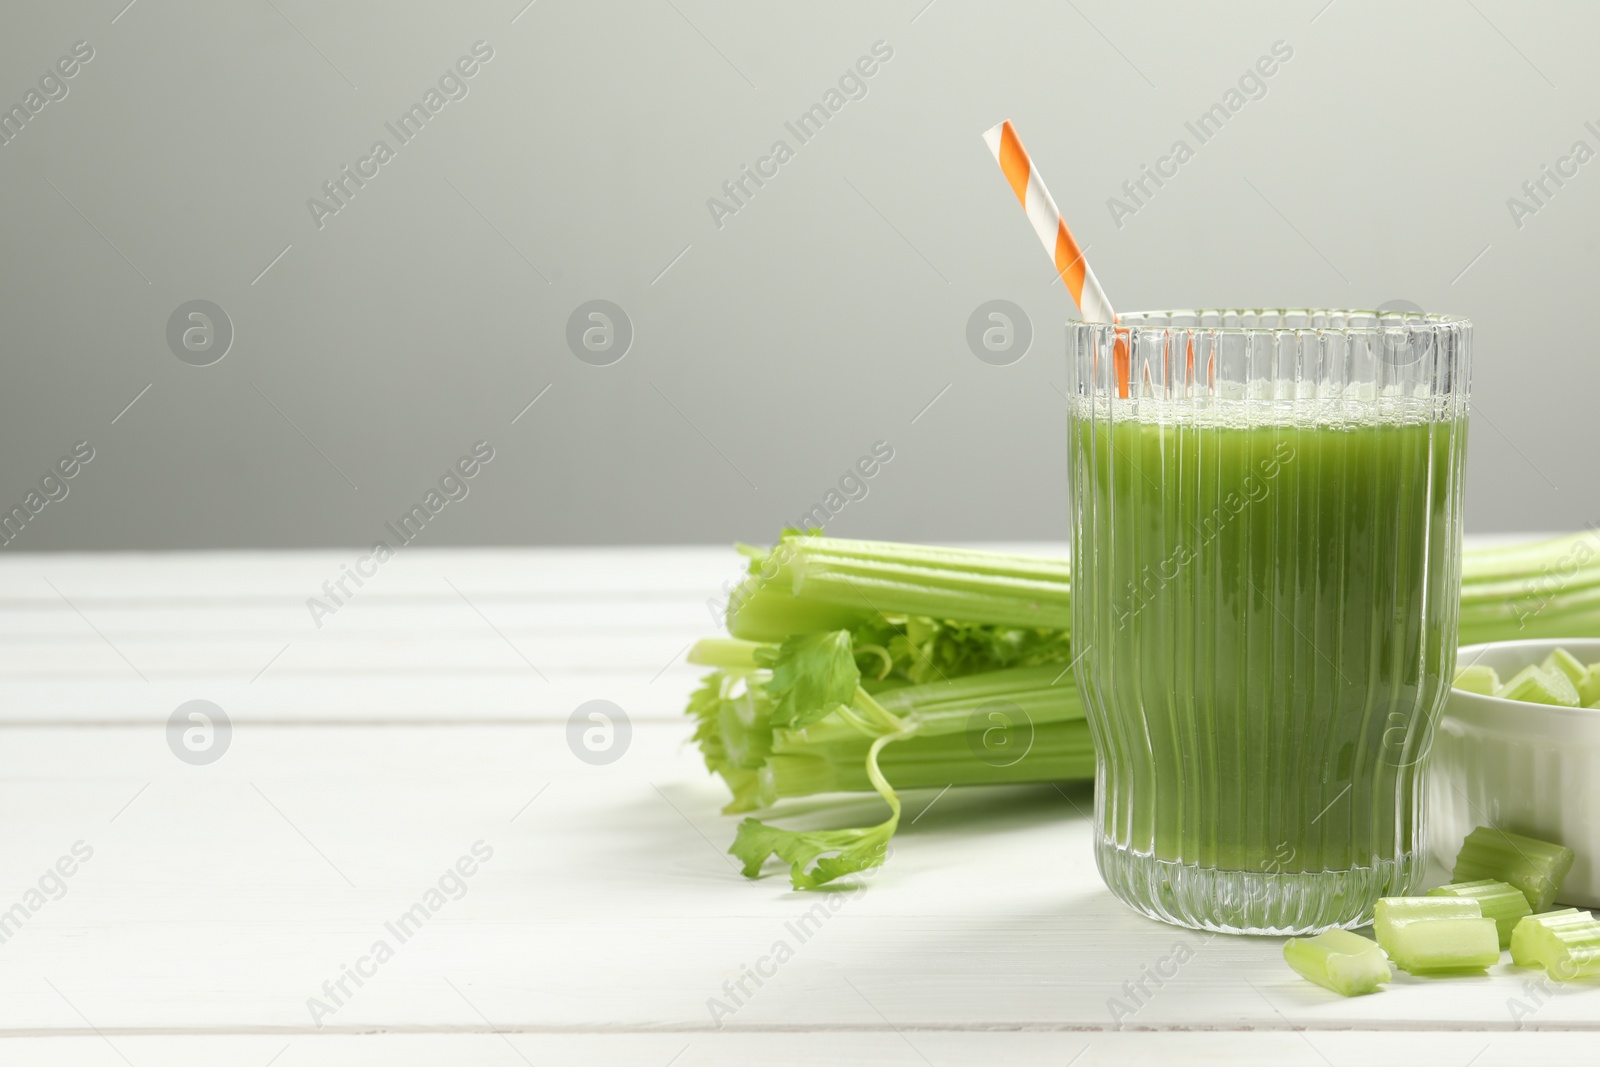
[1067,310,1472,934]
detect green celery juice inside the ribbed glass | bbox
[1070,400,1466,928]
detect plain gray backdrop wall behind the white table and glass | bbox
[0,0,1600,552]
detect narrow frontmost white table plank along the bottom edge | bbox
[0,1025,1594,1067]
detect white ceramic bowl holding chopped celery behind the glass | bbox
[1427,638,1600,907]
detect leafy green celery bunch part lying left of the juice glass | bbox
[688,531,1094,889]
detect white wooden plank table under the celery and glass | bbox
[0,549,1600,1067]
